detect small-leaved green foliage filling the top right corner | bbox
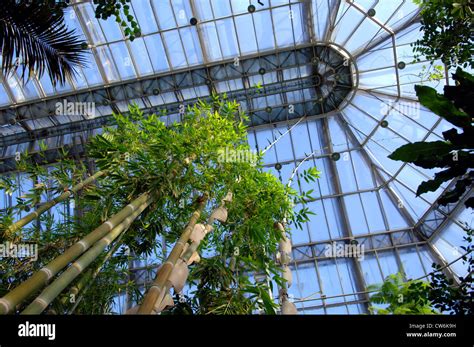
[413,0,474,68]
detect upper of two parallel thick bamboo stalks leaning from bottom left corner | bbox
[0,193,151,314]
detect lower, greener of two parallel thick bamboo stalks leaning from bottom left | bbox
[21,198,152,314]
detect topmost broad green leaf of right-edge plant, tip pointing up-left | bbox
[415,85,471,128]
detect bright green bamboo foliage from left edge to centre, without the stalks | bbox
[0,97,319,314]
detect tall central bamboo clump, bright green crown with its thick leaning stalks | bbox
[3,98,319,314]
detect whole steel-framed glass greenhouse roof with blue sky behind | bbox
[0,0,472,313]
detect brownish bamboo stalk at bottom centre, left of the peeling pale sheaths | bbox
[137,195,208,314]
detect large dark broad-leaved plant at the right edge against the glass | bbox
[389,68,474,208]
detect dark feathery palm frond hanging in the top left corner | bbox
[0,0,87,85]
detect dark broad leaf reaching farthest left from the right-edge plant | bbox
[388,141,454,163]
